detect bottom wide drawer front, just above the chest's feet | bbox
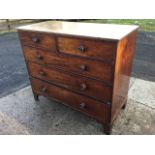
[31,78,110,122]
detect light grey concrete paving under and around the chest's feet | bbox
[0,78,155,135]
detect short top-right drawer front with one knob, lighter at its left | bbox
[57,37,116,62]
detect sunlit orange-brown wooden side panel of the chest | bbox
[111,31,137,122]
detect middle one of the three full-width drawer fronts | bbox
[28,63,112,103]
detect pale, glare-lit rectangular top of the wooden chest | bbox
[17,21,138,40]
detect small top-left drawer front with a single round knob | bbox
[19,31,56,52]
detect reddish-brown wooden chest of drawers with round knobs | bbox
[18,21,138,134]
